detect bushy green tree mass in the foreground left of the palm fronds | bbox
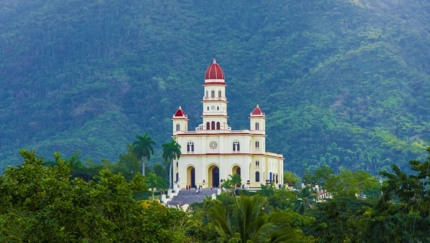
[0,150,187,242]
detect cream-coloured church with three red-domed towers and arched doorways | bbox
[172,59,284,188]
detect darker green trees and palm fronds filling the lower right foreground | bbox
[187,148,430,243]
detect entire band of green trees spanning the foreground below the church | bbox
[0,147,430,243]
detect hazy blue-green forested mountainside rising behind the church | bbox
[0,0,430,173]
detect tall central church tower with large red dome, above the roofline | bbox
[199,58,231,130]
